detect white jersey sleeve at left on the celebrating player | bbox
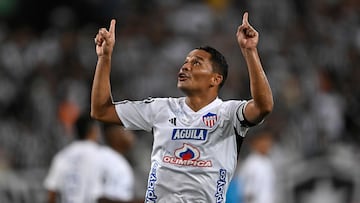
[115,98,157,132]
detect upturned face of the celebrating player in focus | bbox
[177,49,219,94]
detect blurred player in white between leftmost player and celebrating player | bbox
[98,124,144,203]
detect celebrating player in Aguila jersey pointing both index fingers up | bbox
[91,12,273,203]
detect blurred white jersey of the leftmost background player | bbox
[44,141,100,203]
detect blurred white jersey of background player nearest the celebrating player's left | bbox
[99,146,134,201]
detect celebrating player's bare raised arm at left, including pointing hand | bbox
[91,19,121,124]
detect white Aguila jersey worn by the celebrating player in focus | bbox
[116,97,248,203]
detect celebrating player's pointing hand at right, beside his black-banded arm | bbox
[236,12,259,49]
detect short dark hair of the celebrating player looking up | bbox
[196,46,229,88]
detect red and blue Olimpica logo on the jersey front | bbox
[163,143,212,167]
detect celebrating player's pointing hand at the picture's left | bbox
[95,19,116,57]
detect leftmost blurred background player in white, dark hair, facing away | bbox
[44,114,100,203]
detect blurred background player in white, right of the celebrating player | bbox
[238,128,276,203]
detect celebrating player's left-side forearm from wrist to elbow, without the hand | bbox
[91,56,113,118]
